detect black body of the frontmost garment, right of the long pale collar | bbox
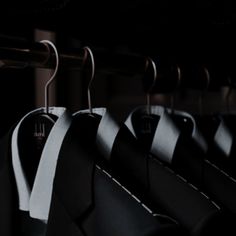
[48,114,180,236]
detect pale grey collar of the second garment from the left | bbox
[74,107,119,160]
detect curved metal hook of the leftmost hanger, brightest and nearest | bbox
[40,40,59,113]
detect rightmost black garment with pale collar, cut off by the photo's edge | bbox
[196,114,236,178]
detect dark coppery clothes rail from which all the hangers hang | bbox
[0,35,234,93]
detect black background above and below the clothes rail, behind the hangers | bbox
[0,0,236,134]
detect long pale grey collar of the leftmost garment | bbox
[11,107,71,221]
